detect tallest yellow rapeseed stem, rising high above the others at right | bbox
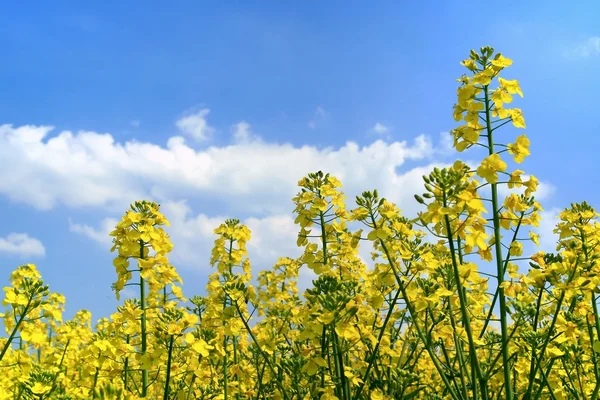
[444,47,538,400]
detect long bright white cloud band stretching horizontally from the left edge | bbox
[0,125,433,214]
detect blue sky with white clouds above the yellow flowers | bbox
[0,1,600,317]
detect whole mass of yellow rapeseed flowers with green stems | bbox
[0,47,600,400]
